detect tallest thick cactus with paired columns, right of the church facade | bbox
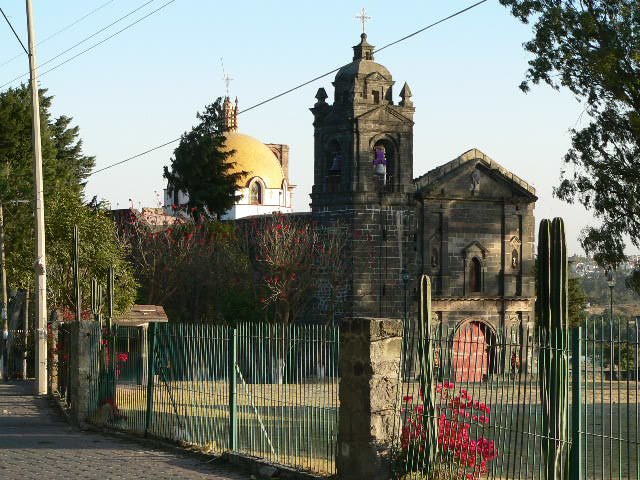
[536,218,569,480]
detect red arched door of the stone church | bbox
[452,321,495,382]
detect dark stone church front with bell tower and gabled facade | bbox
[311,34,537,348]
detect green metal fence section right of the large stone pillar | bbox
[394,319,640,480]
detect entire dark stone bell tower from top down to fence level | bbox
[311,33,415,318]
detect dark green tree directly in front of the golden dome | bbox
[164,98,247,218]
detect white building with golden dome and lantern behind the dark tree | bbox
[164,97,295,220]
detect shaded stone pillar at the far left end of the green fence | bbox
[69,322,97,425]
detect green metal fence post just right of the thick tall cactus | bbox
[569,327,583,480]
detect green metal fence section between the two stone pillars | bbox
[95,323,339,475]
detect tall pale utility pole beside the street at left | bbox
[26,0,47,395]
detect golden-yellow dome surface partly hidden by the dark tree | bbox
[225,132,284,188]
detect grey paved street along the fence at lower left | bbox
[0,382,250,480]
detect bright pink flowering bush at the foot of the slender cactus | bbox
[400,382,498,480]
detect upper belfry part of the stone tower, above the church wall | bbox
[311,33,415,211]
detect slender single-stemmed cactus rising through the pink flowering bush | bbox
[418,275,438,471]
